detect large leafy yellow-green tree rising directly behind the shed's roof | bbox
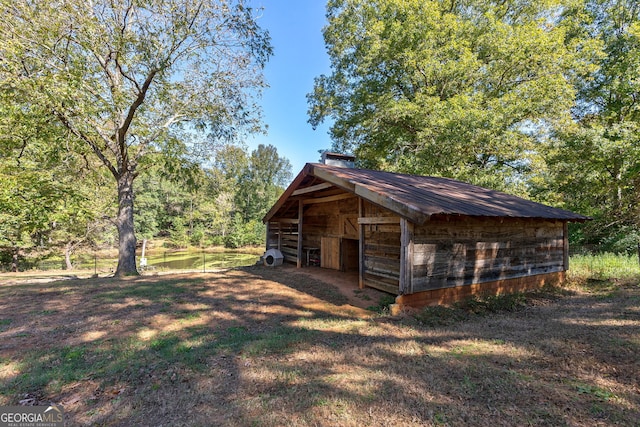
[308,0,589,191]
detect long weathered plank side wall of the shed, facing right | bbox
[405,217,565,293]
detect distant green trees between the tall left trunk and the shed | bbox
[135,144,291,248]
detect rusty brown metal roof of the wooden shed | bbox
[265,163,590,224]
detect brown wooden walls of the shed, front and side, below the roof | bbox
[267,193,567,295]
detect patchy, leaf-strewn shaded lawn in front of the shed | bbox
[0,267,640,427]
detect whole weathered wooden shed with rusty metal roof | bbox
[263,163,589,307]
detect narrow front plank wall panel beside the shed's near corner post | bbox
[360,202,401,294]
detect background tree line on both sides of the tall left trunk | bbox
[0,137,291,269]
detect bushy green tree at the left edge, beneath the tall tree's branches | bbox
[0,92,88,271]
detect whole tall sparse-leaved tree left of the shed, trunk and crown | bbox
[0,0,271,275]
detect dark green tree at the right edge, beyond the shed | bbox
[548,0,640,252]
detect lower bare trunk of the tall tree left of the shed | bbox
[116,171,138,276]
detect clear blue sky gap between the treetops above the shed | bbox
[247,0,331,177]
